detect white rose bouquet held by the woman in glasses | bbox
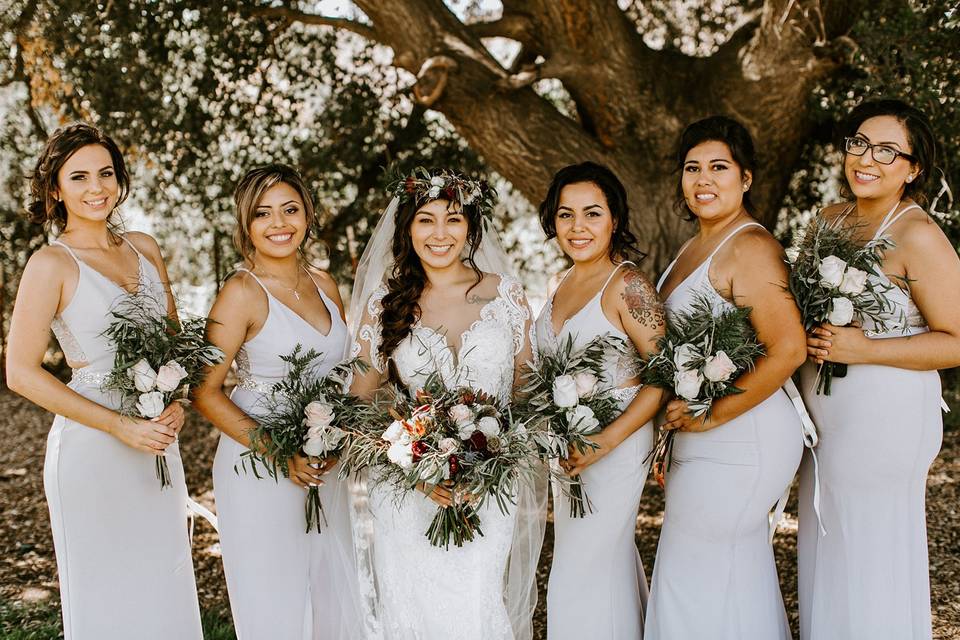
[788,216,894,395]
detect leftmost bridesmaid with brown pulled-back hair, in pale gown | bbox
[7,123,201,640]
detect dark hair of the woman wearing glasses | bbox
[836,99,937,206]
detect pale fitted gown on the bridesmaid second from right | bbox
[645,222,803,640]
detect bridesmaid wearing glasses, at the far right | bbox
[798,100,960,640]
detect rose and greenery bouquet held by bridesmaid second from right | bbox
[641,294,764,484]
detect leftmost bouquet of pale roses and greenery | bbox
[103,294,224,489]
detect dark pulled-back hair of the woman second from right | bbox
[674,116,757,220]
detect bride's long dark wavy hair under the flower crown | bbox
[379,192,483,368]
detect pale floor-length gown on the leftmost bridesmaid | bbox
[43,239,202,640]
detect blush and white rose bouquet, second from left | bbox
[240,345,368,533]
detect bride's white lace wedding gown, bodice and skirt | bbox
[357,276,539,640]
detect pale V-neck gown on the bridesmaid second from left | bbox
[213,272,361,640]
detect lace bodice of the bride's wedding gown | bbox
[354,276,535,401]
